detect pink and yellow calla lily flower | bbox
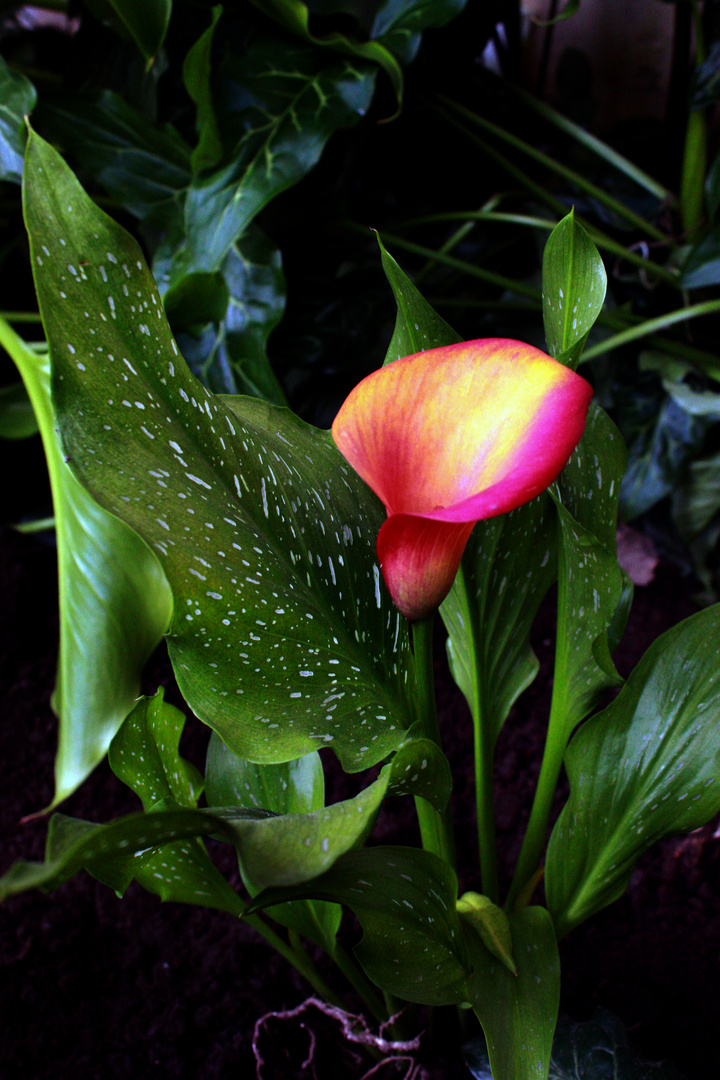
[332,338,593,622]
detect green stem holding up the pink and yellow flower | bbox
[412,616,456,868]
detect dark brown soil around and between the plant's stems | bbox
[0,520,720,1080]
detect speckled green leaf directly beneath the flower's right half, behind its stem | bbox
[440,495,558,743]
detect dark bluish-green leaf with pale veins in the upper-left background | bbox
[161,41,373,285]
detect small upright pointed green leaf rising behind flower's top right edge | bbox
[543,211,608,369]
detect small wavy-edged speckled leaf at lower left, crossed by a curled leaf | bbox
[108,690,248,914]
